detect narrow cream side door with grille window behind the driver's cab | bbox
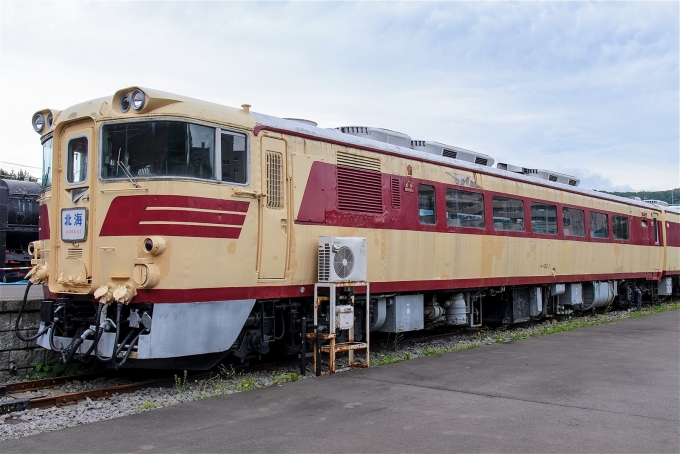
[259,137,288,279]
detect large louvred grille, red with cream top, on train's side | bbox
[337,152,383,213]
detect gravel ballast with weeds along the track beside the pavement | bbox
[0,303,678,440]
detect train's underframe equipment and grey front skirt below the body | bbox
[30,276,680,370]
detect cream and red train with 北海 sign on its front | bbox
[23,87,680,368]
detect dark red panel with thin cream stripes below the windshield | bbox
[99,195,250,239]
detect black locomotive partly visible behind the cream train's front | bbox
[0,179,40,282]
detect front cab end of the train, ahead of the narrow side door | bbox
[30,87,257,369]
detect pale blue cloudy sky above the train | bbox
[0,1,680,190]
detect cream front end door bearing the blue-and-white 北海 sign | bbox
[51,121,97,293]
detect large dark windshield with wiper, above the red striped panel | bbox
[101,121,215,179]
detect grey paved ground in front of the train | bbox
[0,311,680,453]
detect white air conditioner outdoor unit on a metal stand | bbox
[319,236,366,282]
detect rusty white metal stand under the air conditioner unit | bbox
[307,282,371,375]
